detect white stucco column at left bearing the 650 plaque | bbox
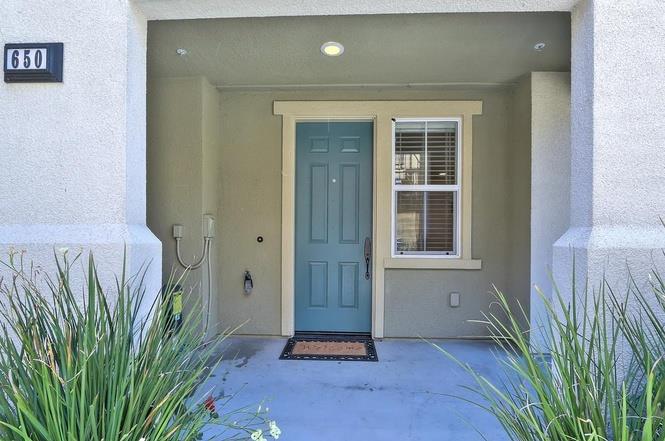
[0,0,161,295]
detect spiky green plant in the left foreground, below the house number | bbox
[0,254,272,441]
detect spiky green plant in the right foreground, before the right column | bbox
[437,272,665,441]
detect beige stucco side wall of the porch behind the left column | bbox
[147,77,221,334]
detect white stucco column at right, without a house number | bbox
[553,0,665,306]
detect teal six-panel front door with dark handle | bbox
[295,118,374,332]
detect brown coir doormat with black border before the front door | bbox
[279,333,379,361]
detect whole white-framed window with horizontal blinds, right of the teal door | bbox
[392,118,462,258]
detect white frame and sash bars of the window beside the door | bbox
[390,117,464,259]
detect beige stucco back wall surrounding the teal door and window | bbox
[217,87,529,337]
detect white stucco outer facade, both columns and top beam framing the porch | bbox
[0,0,665,350]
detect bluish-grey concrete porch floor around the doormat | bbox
[204,337,508,441]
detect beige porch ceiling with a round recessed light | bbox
[148,13,570,87]
